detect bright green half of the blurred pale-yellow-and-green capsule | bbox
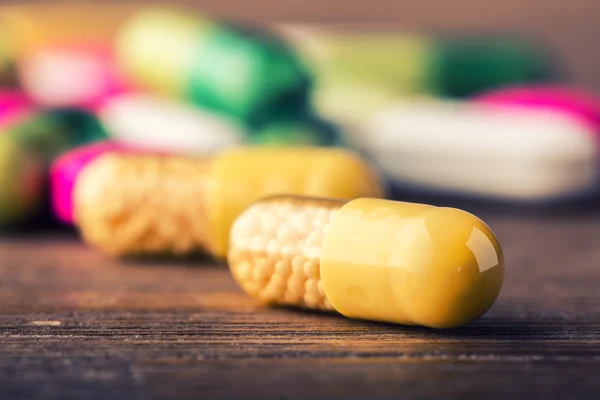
[189,25,310,123]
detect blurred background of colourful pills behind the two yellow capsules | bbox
[0,0,600,244]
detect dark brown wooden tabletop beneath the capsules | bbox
[0,211,600,400]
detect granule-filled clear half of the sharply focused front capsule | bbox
[229,196,345,310]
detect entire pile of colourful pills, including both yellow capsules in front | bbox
[0,2,600,328]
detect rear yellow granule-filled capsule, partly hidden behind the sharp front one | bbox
[73,148,382,258]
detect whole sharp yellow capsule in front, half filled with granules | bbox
[228,196,504,328]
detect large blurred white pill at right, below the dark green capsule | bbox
[364,102,599,201]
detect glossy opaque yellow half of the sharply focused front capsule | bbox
[321,199,504,328]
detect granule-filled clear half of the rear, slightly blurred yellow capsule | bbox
[74,154,209,255]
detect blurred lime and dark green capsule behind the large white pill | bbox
[279,24,553,125]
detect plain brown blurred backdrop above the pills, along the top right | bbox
[146,0,600,90]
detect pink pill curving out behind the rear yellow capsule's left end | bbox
[50,141,133,225]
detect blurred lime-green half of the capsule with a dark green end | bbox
[278,24,429,125]
